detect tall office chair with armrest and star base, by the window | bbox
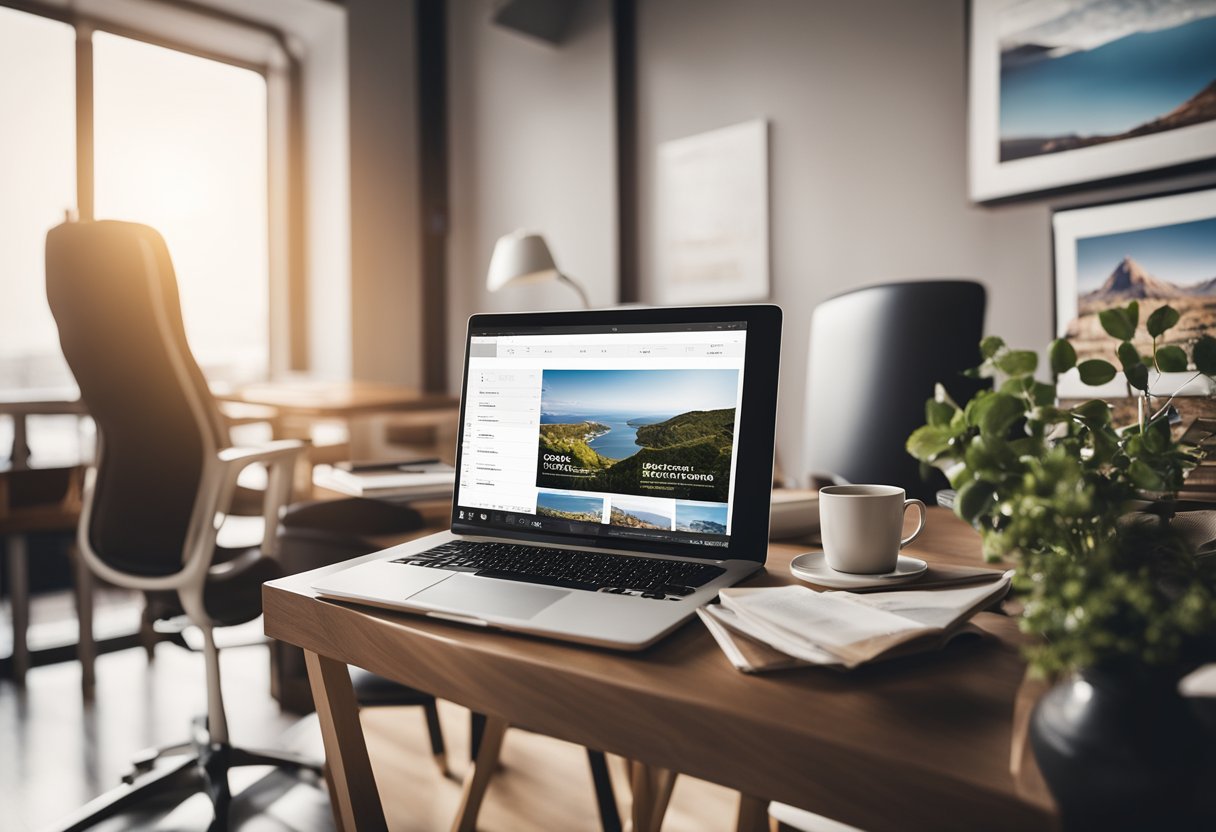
[46,217,330,830]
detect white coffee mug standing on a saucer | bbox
[820,485,925,574]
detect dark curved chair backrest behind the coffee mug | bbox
[805,280,986,500]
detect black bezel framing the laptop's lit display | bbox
[451,304,782,563]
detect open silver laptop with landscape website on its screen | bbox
[311,304,782,650]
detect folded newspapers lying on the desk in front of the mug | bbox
[697,572,1013,673]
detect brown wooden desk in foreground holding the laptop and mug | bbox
[263,508,1054,832]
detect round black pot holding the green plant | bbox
[1030,670,1211,832]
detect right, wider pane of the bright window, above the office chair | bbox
[92,32,270,381]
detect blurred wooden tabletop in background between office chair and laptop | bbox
[215,381,460,417]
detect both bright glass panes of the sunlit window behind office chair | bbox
[0,7,286,389]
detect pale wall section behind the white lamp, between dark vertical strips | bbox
[447,0,617,392]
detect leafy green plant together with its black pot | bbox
[907,302,1216,828]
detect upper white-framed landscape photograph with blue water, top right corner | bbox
[968,0,1216,202]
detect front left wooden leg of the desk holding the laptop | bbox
[304,650,388,832]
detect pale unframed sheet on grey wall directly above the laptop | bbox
[655,119,769,304]
